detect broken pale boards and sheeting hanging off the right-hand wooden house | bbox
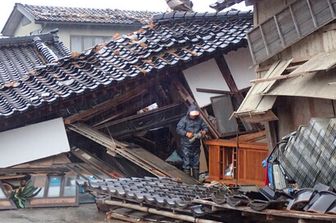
[234,49,336,122]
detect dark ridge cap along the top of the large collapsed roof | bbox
[153,9,252,22]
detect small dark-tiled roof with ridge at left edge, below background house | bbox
[0,34,70,83]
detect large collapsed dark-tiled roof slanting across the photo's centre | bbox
[0,11,252,116]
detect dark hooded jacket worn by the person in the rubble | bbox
[176,105,208,146]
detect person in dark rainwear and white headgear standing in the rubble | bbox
[176,105,208,180]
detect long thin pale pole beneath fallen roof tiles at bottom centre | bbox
[101,200,219,223]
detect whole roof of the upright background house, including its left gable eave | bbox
[2,3,158,35]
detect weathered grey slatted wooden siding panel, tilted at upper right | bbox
[248,0,336,64]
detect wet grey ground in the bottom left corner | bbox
[0,204,120,223]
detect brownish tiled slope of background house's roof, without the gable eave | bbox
[22,4,157,24]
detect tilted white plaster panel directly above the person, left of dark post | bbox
[183,59,229,107]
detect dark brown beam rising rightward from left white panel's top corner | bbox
[64,84,151,124]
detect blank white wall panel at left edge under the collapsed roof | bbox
[0,118,70,168]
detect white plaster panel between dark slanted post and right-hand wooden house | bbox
[224,48,256,90]
